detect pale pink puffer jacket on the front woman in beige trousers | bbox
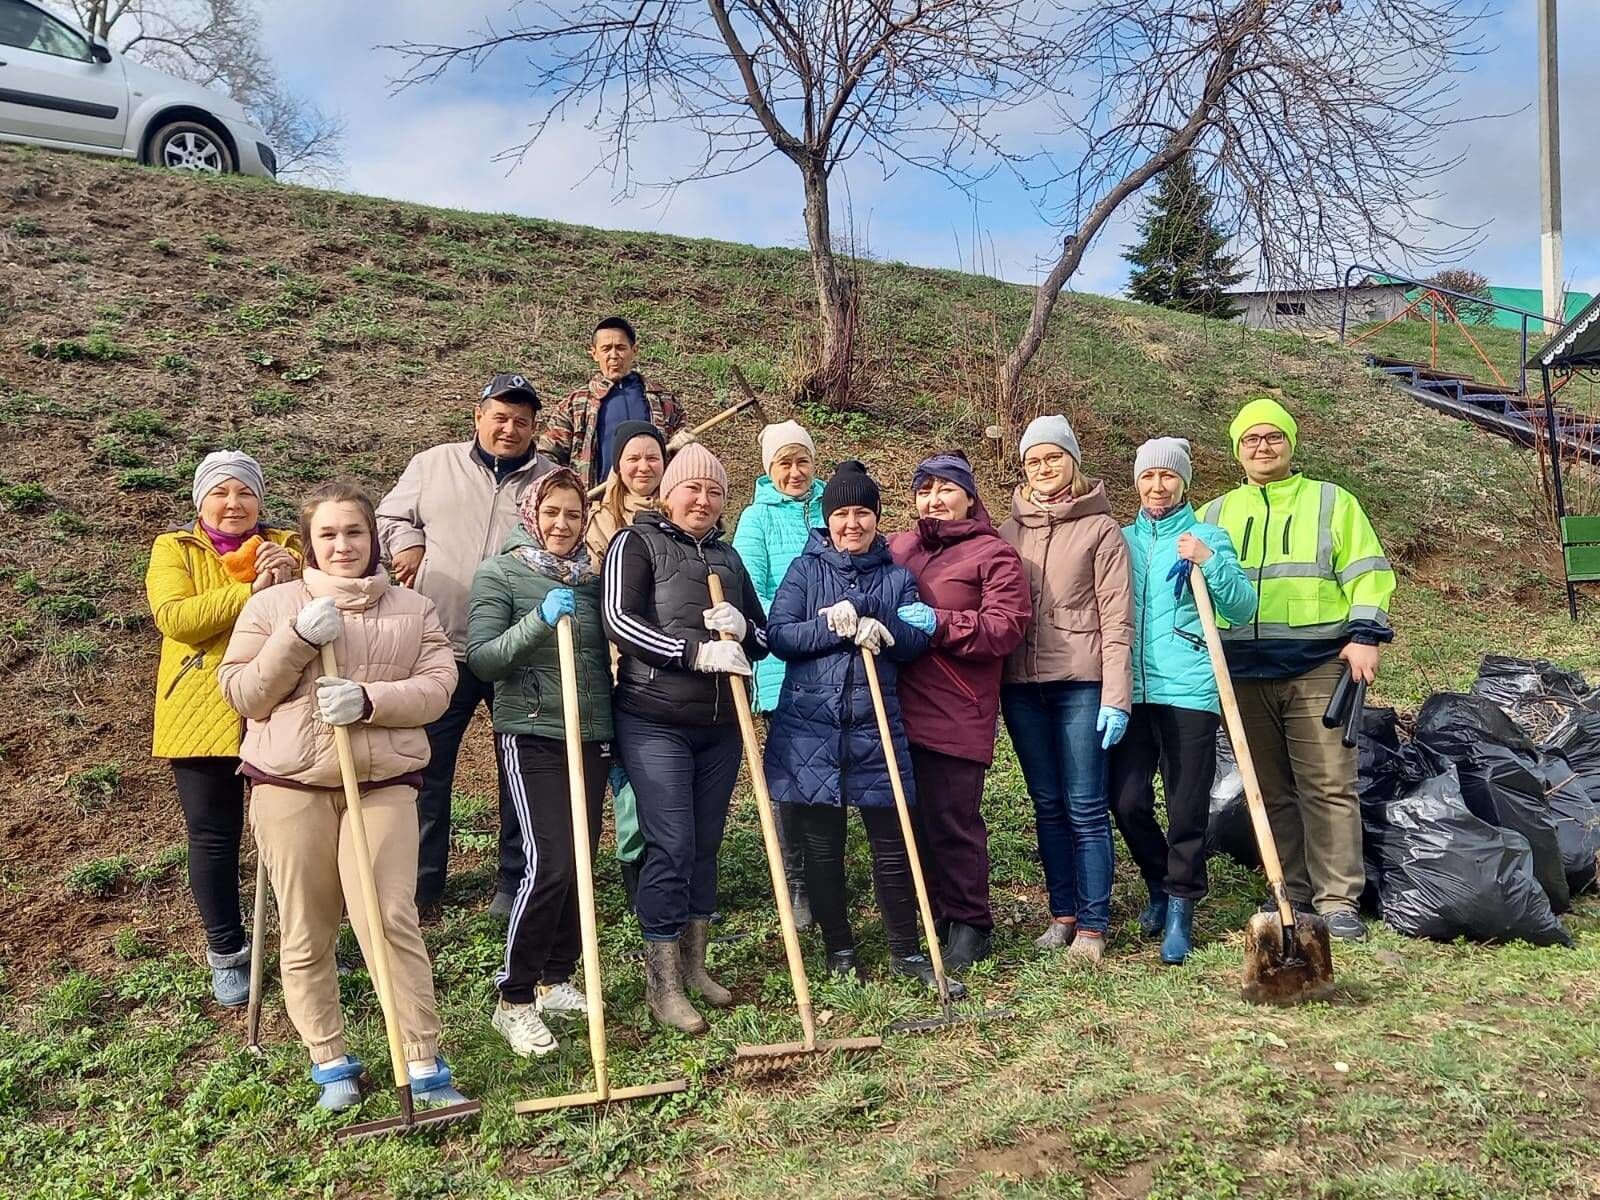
[216,570,456,789]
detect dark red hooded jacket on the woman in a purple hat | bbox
[890,501,1034,765]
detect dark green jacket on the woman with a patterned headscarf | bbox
[467,525,613,742]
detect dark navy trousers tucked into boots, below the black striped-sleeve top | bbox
[613,709,742,941]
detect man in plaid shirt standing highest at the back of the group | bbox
[539,317,688,486]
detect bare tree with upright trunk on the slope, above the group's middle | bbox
[389,0,1053,400]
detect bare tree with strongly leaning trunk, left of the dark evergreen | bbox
[1000,0,1483,422]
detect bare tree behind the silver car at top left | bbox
[70,0,344,182]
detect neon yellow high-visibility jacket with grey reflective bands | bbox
[1202,475,1395,645]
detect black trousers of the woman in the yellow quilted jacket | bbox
[173,758,245,954]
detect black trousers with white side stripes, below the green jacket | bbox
[494,733,611,1005]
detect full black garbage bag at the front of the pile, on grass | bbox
[1363,768,1573,946]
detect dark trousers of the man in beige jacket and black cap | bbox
[416,659,523,907]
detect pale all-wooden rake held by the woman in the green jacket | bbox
[512,616,690,1112]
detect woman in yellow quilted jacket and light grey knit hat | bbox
[144,450,299,1006]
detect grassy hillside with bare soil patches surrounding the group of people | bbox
[0,149,1600,1197]
